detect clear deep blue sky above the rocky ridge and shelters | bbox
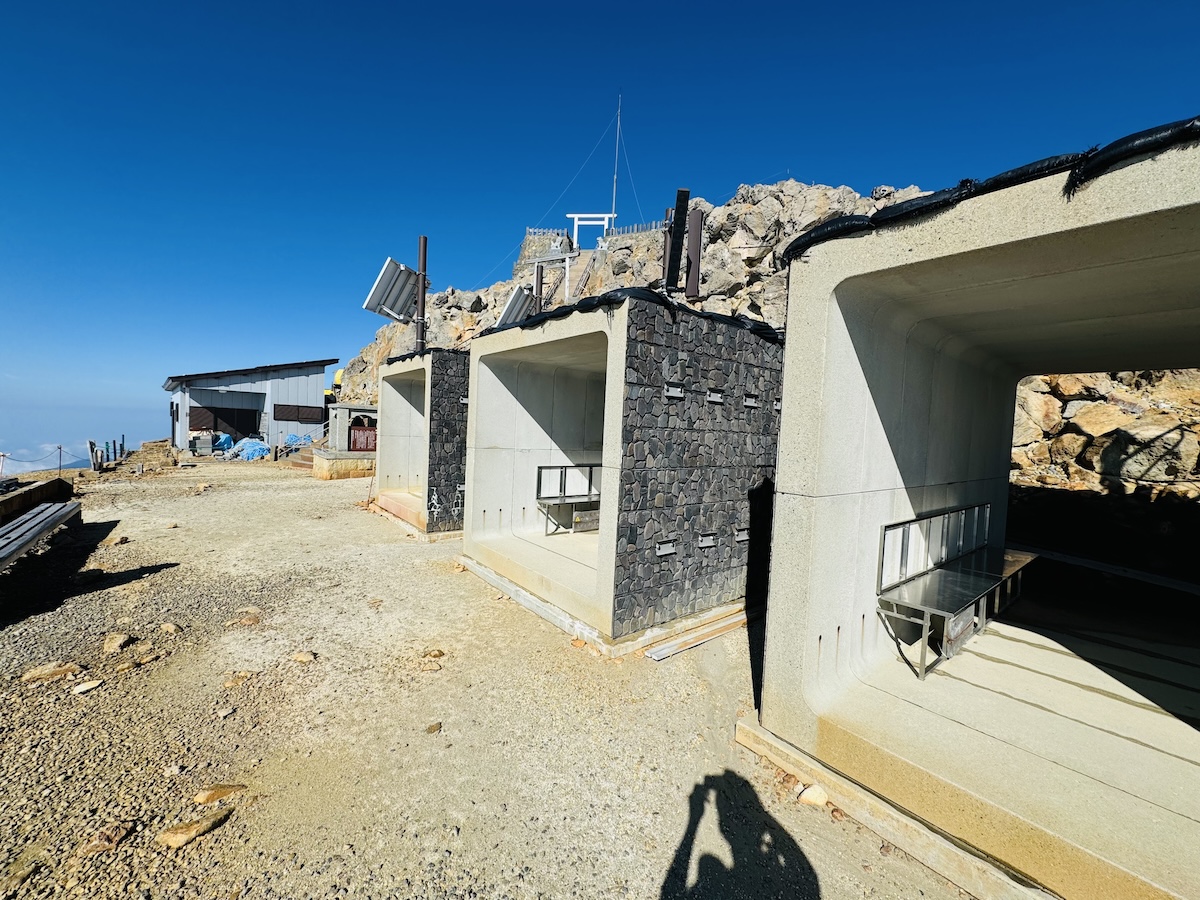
[0,0,1200,469]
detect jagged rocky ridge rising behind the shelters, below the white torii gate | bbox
[340,180,922,403]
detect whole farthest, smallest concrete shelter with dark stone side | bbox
[374,349,468,534]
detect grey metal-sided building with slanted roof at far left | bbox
[162,359,337,449]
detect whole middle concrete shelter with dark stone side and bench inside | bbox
[463,296,782,653]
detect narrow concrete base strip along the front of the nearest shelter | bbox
[734,720,1052,900]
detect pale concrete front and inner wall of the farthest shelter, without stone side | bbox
[376,356,431,497]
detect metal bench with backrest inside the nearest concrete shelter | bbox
[878,503,1037,680]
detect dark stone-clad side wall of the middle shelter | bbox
[612,300,784,637]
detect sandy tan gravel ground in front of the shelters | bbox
[0,463,965,900]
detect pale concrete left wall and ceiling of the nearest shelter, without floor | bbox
[761,148,1200,753]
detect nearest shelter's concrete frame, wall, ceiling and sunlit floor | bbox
[761,148,1200,896]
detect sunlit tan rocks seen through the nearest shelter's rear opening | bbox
[1012,370,1200,499]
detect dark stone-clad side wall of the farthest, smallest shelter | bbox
[425,349,470,532]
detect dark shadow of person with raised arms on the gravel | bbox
[660,769,821,900]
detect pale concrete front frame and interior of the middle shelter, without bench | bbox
[463,307,626,635]
